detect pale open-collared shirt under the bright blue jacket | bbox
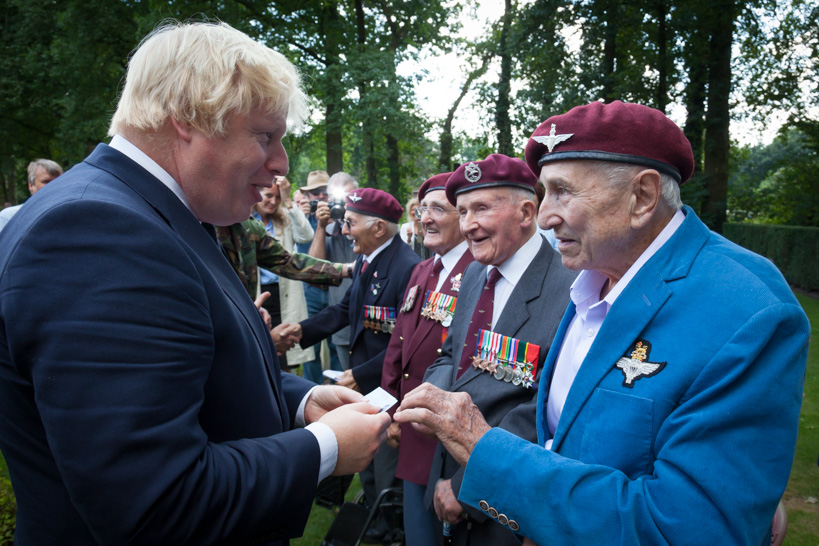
[545,210,685,449]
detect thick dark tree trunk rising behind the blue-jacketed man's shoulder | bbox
[702,0,736,233]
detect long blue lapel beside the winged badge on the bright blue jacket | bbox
[552,207,708,451]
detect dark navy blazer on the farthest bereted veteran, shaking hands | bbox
[301,235,420,394]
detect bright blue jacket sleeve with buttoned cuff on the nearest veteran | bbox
[459,303,809,544]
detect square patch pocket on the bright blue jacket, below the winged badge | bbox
[580,389,654,479]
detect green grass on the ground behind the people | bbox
[0,288,819,546]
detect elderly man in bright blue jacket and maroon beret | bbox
[395,102,809,545]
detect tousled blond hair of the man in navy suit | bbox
[108,22,307,136]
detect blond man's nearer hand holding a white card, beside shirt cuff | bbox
[319,402,390,476]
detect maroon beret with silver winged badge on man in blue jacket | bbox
[525,101,694,184]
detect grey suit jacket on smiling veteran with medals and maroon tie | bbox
[424,235,577,546]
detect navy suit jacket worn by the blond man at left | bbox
[0,145,320,545]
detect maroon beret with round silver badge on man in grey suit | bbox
[446,154,537,205]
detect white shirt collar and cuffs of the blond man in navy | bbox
[109,135,340,482]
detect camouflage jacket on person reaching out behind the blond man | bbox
[214,218,344,298]
